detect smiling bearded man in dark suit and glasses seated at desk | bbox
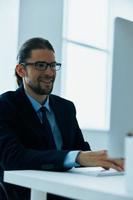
[0,38,123,200]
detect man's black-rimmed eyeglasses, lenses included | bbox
[21,61,61,71]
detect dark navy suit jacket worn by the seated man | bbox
[0,87,90,200]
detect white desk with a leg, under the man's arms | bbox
[4,170,133,200]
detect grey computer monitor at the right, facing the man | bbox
[108,17,133,158]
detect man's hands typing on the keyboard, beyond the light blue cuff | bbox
[76,150,124,171]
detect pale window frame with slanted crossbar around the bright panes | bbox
[61,0,111,131]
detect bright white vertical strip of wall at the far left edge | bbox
[0,0,19,93]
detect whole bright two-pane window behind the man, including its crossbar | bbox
[62,0,108,129]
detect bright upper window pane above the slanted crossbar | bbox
[64,0,108,48]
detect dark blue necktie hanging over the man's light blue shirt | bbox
[40,106,56,148]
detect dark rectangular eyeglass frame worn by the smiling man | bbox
[20,61,61,71]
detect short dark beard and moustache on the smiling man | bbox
[28,77,55,95]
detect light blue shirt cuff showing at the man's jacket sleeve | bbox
[64,151,80,168]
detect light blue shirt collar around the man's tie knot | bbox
[25,92,51,112]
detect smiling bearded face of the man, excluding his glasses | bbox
[23,49,56,95]
